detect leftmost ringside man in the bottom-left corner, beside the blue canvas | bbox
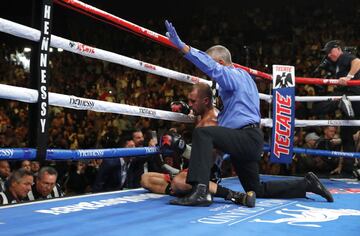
[0,168,34,205]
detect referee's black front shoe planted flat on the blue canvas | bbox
[170,184,213,206]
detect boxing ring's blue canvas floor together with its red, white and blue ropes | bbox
[0,0,360,235]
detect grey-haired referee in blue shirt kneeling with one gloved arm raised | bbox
[165,21,333,206]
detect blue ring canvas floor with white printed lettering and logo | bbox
[0,175,360,236]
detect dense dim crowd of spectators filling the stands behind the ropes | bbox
[0,1,360,204]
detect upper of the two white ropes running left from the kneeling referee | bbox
[0,18,212,86]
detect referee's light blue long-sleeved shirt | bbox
[185,47,261,129]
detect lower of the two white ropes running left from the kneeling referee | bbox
[0,84,194,123]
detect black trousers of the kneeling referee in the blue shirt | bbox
[187,126,306,198]
